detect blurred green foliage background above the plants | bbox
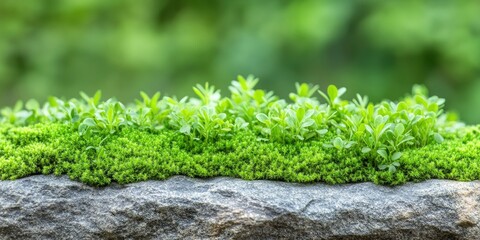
[0,0,480,123]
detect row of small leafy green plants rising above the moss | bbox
[0,76,461,183]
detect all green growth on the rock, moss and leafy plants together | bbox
[0,76,480,186]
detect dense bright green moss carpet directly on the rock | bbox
[0,123,480,186]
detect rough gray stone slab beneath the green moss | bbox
[0,175,480,240]
